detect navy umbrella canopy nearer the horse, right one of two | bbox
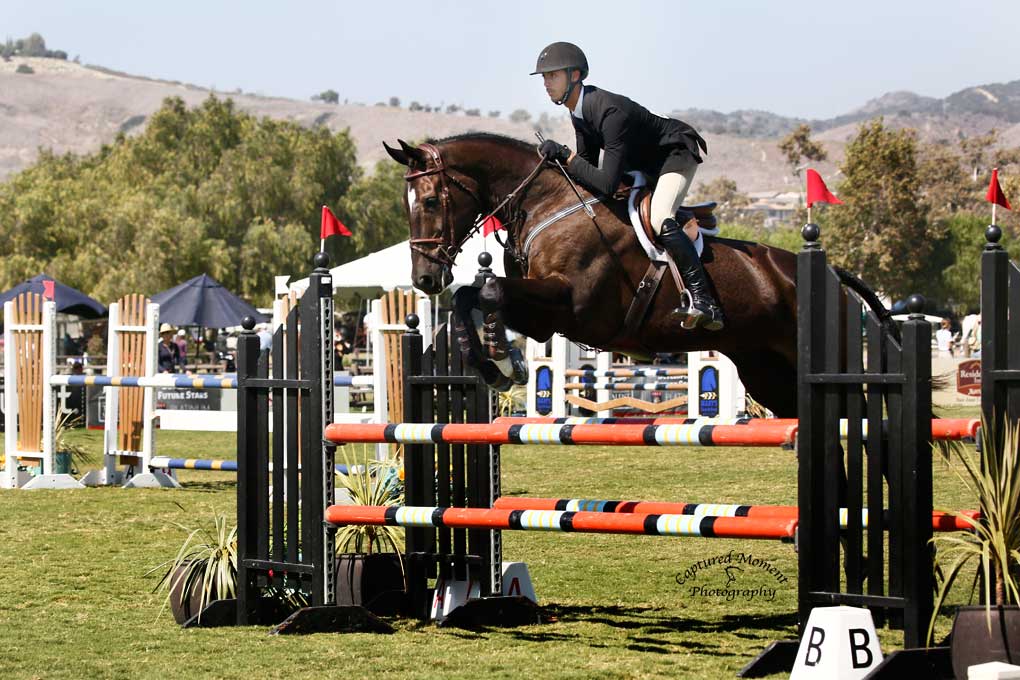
[151,274,265,328]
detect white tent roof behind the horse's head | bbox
[290,236,504,297]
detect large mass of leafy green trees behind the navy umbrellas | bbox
[0,96,361,305]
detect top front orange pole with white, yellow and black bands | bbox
[325,423,797,447]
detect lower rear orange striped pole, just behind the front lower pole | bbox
[493,495,980,531]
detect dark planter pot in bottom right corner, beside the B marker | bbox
[951,605,1020,678]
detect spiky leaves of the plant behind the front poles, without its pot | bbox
[337,444,404,555]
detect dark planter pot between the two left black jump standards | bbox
[337,553,405,616]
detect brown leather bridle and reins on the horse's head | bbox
[404,144,545,268]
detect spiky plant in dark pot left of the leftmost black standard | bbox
[146,504,238,624]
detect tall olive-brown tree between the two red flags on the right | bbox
[819,118,949,299]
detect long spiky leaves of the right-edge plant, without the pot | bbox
[928,421,1020,640]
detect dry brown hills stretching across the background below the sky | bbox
[0,57,1020,192]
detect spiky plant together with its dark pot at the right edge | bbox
[928,415,1020,677]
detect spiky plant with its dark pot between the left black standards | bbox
[336,444,405,615]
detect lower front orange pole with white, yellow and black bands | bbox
[325,506,797,540]
